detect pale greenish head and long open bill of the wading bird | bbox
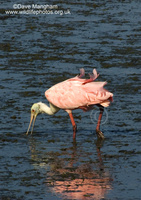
[26,102,41,135]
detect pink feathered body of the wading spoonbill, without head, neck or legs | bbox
[45,69,113,112]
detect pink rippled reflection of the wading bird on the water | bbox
[28,138,112,200]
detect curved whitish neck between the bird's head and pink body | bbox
[38,102,60,115]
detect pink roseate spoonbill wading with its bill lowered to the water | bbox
[26,68,113,140]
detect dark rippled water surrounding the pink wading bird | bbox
[0,0,141,200]
